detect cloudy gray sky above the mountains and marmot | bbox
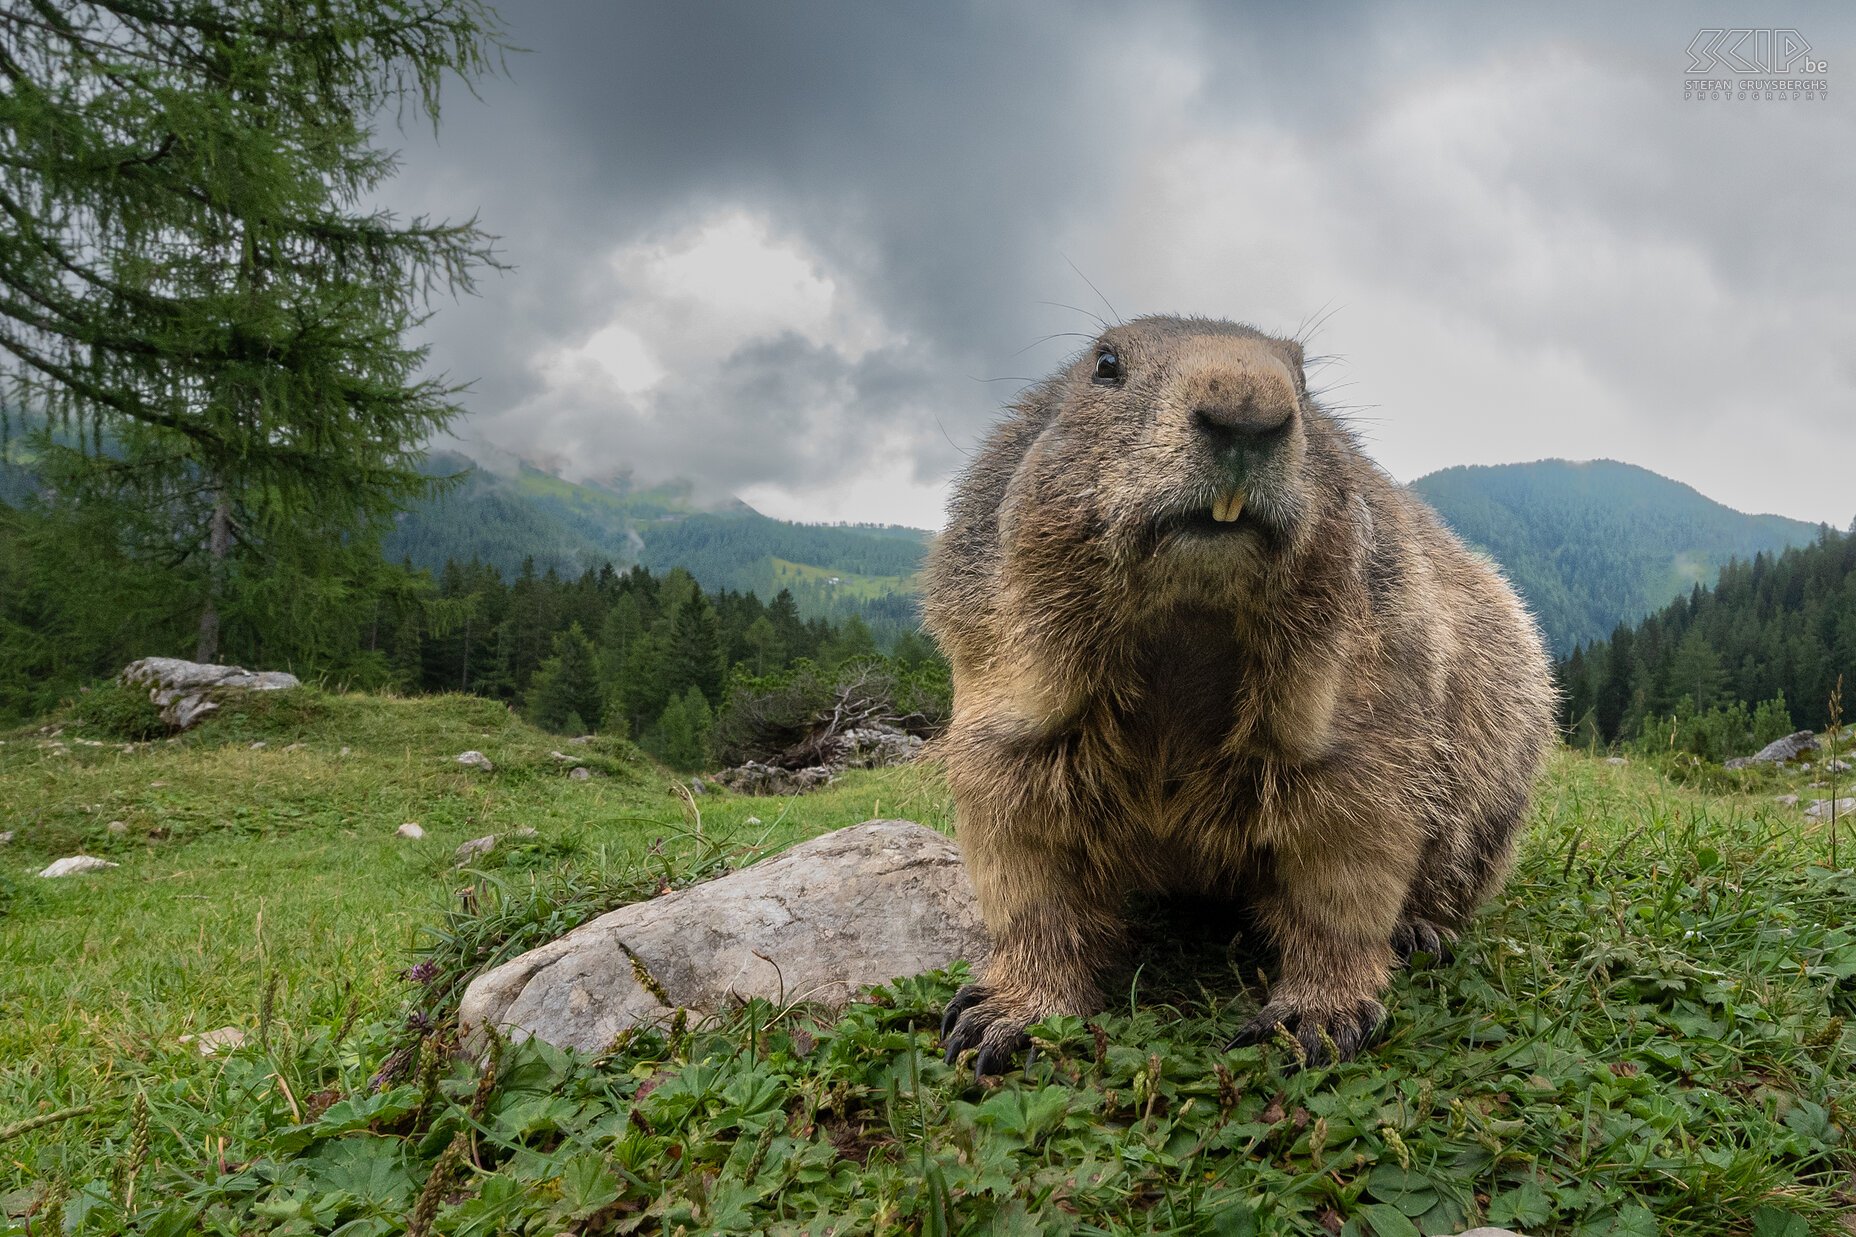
[392,0,1856,526]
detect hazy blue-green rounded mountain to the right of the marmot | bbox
[1411,459,1819,656]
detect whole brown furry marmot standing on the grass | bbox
[924,318,1553,1074]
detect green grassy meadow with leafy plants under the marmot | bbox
[0,689,1856,1237]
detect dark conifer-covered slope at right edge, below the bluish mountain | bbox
[1561,529,1856,742]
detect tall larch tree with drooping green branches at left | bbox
[0,0,501,661]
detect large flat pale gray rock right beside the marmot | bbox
[458,821,989,1051]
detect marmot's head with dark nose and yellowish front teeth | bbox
[1000,308,1344,598]
